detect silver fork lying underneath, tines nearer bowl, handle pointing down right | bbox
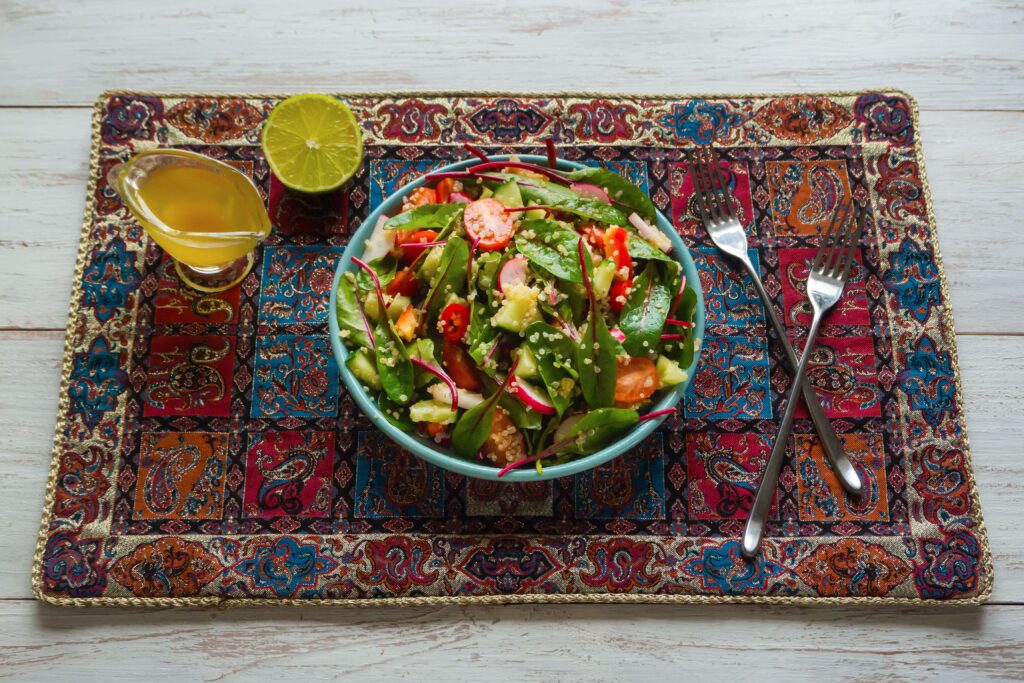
[686,148,862,494]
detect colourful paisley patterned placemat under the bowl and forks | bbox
[33,92,992,605]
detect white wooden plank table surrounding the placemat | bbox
[0,0,1024,681]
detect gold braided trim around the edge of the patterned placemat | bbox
[32,88,993,608]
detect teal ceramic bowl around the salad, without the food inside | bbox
[328,155,705,482]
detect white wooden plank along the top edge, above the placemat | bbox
[0,0,1024,110]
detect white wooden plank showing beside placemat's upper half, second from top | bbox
[0,110,1024,334]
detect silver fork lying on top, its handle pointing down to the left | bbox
[742,201,863,557]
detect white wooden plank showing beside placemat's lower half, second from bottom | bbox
[0,332,1024,603]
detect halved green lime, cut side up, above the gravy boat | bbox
[263,93,362,193]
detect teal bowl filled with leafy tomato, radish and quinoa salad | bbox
[330,147,703,481]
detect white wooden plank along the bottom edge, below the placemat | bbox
[0,601,1024,683]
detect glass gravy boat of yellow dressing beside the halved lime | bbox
[112,150,271,292]
